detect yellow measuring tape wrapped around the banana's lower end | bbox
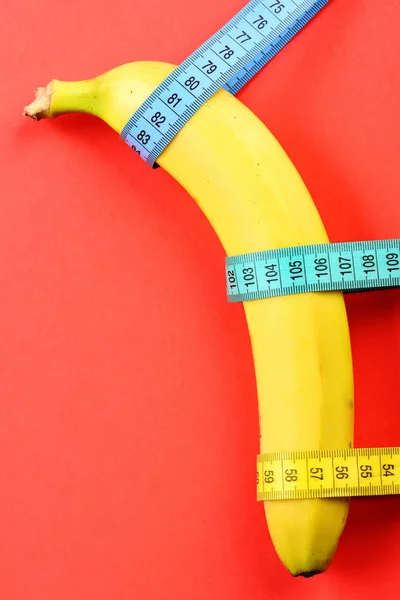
[257,447,400,500]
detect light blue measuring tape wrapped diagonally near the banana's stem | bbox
[121,0,330,167]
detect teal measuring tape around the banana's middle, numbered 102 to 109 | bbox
[225,239,400,302]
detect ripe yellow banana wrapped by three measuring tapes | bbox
[24,62,354,577]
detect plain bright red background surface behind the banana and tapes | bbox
[0,0,400,600]
